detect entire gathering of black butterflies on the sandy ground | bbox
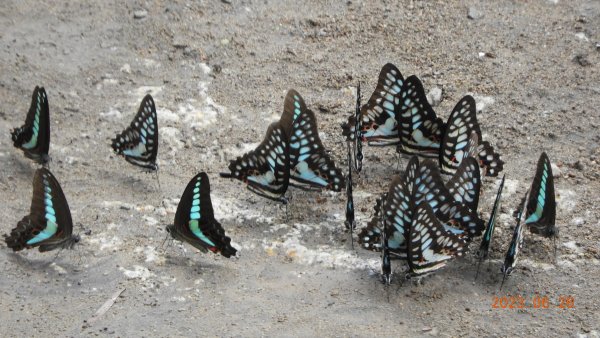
[5,64,558,290]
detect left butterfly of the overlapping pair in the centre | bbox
[220,121,291,204]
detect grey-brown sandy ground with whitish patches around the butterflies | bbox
[0,0,600,337]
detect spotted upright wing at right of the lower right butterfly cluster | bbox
[446,157,481,212]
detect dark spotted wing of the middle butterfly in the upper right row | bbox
[396,75,445,157]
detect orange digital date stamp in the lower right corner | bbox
[492,295,575,310]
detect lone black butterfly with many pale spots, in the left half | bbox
[111,94,158,171]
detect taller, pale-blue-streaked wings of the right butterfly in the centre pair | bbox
[280,89,345,191]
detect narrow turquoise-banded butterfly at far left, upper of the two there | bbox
[11,86,50,164]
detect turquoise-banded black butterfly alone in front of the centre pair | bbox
[167,172,237,258]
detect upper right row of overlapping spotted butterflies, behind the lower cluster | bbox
[342,63,504,176]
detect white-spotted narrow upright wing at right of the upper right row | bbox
[440,95,481,174]
